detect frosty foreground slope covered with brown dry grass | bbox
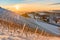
[0,20,60,40]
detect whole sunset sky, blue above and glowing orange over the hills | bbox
[0,0,60,11]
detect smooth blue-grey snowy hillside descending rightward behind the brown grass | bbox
[0,8,60,36]
